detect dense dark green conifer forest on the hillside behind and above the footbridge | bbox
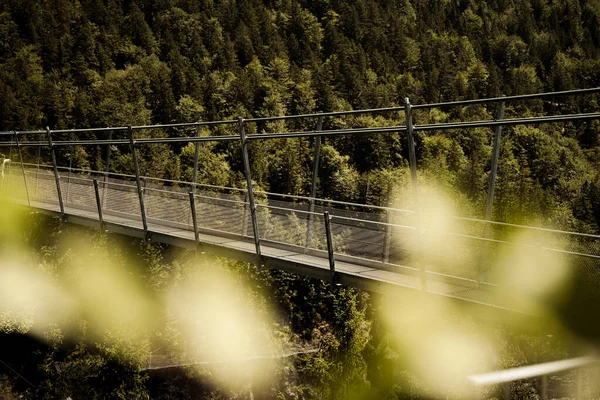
[0,0,600,227]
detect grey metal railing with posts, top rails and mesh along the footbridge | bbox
[0,88,600,290]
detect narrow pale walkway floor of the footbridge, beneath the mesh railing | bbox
[17,200,521,318]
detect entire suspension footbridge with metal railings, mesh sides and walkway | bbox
[0,88,600,322]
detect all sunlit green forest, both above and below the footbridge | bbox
[0,0,600,399]
